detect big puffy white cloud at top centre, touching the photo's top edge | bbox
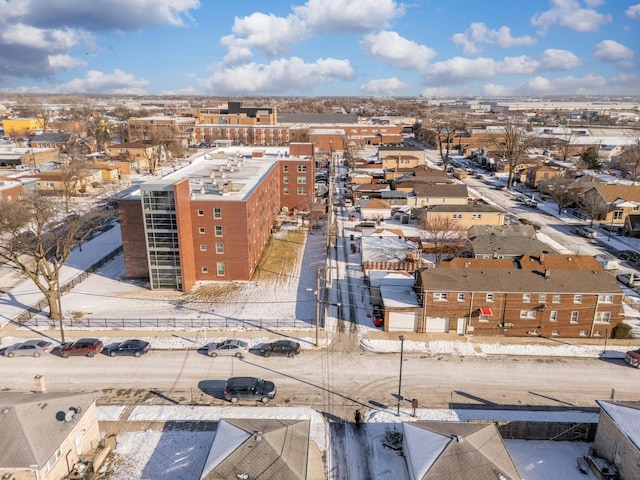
[221,0,404,58]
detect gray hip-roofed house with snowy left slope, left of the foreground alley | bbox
[200,418,312,480]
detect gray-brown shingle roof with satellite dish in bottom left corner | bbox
[0,392,96,468]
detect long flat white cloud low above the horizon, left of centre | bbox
[199,57,355,95]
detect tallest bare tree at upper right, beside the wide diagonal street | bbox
[489,115,534,187]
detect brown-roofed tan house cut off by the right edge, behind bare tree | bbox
[581,184,640,227]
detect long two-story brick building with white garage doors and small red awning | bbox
[416,254,624,338]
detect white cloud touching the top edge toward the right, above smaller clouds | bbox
[531,0,612,34]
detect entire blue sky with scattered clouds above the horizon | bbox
[0,0,640,96]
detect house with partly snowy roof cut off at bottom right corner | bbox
[594,400,640,480]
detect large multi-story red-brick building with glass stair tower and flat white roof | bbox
[118,143,315,292]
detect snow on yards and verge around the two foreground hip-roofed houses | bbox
[98,406,598,480]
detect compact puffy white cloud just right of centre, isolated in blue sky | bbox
[360,30,436,71]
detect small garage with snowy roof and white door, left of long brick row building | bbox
[380,285,422,332]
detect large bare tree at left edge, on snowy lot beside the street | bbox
[0,194,113,342]
